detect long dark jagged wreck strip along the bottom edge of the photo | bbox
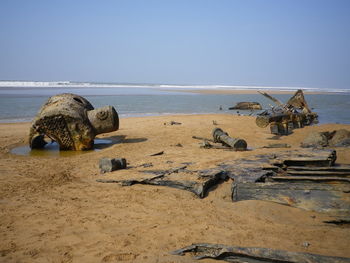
[171,243,350,263]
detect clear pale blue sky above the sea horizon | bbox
[0,0,350,88]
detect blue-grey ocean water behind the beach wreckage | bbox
[0,86,350,124]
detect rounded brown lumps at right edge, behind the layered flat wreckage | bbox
[301,129,350,148]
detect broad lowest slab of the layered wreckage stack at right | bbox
[232,182,350,219]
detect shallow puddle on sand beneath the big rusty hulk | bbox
[11,139,113,157]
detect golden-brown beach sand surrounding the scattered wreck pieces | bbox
[0,115,350,263]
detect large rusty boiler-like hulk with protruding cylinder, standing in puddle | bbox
[29,93,119,150]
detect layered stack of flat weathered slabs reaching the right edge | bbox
[232,150,350,222]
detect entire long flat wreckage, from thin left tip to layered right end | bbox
[97,149,350,222]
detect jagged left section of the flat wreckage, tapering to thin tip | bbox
[97,167,227,198]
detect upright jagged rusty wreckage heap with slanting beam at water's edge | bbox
[256,90,318,135]
